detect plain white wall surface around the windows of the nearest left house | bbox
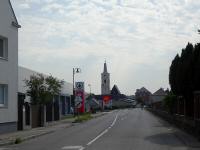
[0,0,18,123]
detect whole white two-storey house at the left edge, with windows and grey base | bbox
[0,0,20,133]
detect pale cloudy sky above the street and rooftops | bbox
[11,0,200,95]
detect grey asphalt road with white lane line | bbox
[1,109,200,150]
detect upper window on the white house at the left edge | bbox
[0,36,8,59]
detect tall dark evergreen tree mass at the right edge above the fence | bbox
[169,43,200,116]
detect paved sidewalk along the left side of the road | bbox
[0,112,106,146]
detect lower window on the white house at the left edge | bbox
[0,84,8,107]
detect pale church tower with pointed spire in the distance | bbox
[101,62,110,95]
